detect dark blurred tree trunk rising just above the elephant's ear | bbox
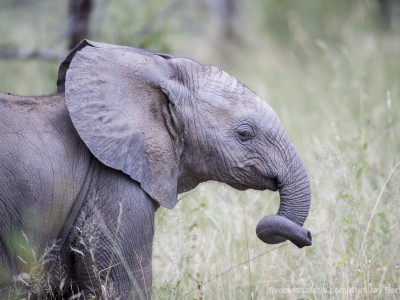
[68,0,93,49]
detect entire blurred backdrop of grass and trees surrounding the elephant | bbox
[0,0,400,299]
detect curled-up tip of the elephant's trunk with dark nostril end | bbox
[256,215,312,248]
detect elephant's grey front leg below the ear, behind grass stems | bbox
[67,168,158,299]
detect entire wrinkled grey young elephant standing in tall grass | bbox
[0,41,311,298]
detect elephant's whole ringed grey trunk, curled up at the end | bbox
[256,146,312,248]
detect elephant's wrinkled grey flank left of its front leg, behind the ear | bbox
[0,94,91,240]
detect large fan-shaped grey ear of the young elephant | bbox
[57,41,183,208]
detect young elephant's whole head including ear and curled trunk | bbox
[58,41,311,247]
